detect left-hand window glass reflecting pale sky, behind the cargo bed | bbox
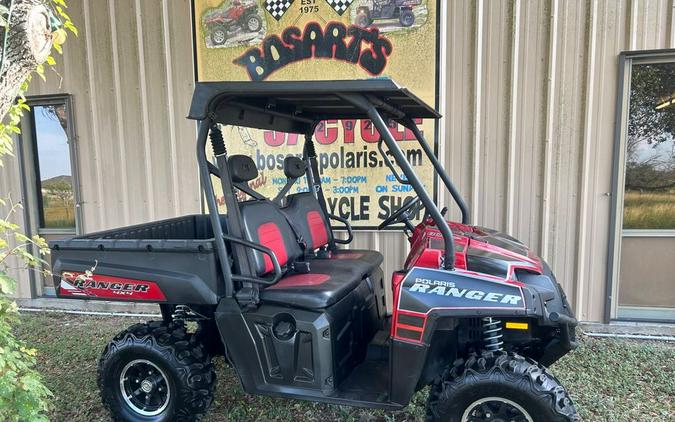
[31,104,75,229]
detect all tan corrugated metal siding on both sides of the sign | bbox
[0,0,675,320]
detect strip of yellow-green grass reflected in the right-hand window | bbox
[623,191,675,230]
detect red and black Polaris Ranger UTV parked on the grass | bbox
[51,79,578,422]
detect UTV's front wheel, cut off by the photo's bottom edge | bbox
[427,352,580,422]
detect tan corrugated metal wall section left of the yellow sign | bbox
[26,0,200,231]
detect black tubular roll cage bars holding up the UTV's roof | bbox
[197,92,469,301]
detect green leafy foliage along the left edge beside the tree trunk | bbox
[0,0,77,422]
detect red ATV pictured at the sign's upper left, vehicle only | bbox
[202,0,263,45]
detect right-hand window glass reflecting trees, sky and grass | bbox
[623,63,675,230]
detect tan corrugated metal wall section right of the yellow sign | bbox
[443,0,675,320]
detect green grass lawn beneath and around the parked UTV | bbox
[17,313,675,422]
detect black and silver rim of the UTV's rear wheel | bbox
[120,359,171,416]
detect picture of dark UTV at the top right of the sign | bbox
[351,0,429,32]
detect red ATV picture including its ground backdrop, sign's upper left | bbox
[202,0,266,47]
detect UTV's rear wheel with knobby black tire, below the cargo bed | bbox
[98,321,215,422]
